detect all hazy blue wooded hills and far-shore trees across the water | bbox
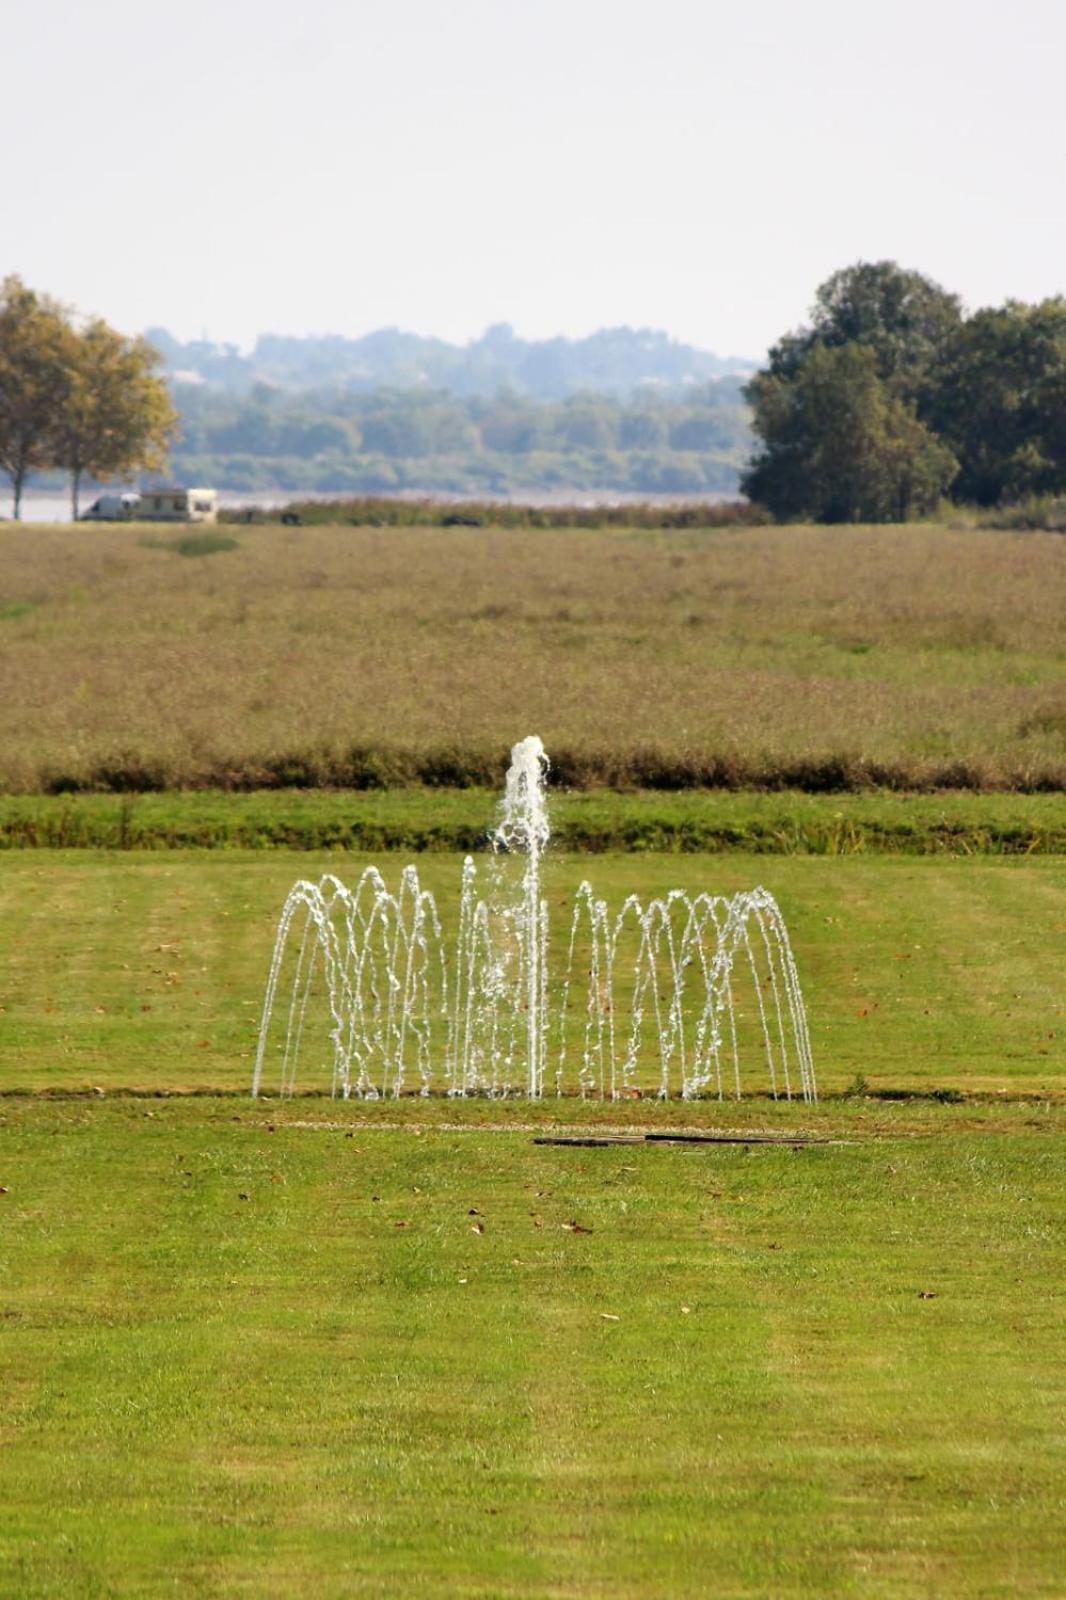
[149,325,754,494]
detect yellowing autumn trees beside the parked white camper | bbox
[0,277,178,520]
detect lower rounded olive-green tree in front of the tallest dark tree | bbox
[741,342,959,522]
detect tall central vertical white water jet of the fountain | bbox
[493,733,552,1099]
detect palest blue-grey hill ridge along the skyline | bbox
[147,323,755,400]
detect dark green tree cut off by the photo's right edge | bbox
[928,298,1066,506]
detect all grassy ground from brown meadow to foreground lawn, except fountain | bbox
[0,526,1066,1600]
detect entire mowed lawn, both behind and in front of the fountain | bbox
[0,848,1066,1600]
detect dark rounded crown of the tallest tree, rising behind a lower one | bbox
[758,261,962,402]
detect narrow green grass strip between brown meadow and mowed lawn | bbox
[0,789,1066,856]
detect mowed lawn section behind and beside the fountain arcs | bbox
[0,850,1066,1094]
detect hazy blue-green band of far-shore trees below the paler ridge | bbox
[168,378,751,493]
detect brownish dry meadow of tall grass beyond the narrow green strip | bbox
[0,525,1066,792]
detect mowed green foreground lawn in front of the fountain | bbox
[0,1100,1064,1600]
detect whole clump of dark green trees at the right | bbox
[741,261,1066,522]
